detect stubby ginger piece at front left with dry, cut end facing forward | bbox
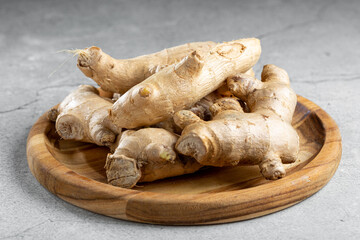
[105,128,202,188]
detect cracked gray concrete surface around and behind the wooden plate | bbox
[0,0,360,239]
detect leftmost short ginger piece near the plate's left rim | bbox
[48,85,121,146]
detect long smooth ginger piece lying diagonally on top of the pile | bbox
[110,38,261,129]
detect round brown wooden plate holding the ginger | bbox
[27,96,341,225]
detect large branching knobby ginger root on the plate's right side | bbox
[174,65,299,179]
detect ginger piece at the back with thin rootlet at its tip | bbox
[77,42,216,94]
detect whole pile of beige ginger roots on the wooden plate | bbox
[48,38,299,188]
